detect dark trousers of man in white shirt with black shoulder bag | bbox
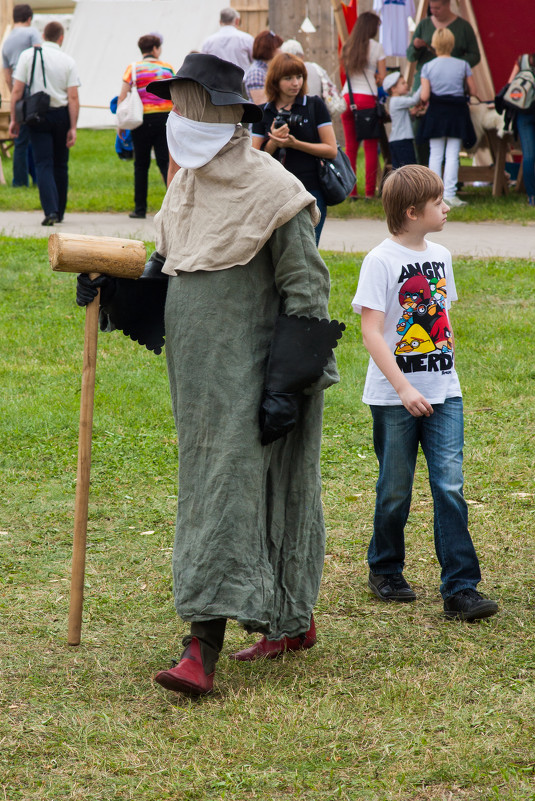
[30,106,70,220]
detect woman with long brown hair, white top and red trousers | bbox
[341,11,386,198]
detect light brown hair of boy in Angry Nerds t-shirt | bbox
[382,164,444,236]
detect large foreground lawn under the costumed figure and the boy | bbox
[0,239,535,801]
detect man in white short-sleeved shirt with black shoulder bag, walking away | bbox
[9,22,80,225]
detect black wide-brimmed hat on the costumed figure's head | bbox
[146,53,262,122]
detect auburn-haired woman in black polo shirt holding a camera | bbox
[252,53,337,244]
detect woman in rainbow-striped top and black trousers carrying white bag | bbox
[118,34,174,219]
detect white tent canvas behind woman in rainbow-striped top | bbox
[62,0,225,128]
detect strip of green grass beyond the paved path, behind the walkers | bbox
[0,130,535,223]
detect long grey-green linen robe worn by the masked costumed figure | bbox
[165,209,338,639]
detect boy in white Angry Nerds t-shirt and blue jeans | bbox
[352,165,498,620]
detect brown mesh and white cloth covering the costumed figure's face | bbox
[166,81,243,170]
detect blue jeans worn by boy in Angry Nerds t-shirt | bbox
[368,398,481,598]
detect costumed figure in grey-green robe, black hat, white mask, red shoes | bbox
[78,54,344,695]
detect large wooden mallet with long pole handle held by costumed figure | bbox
[48,234,146,645]
